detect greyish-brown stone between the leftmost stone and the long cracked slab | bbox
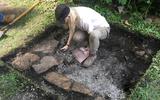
[32,56,63,74]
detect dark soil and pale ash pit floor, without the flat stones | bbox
[2,26,160,100]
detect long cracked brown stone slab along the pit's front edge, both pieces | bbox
[44,72,93,96]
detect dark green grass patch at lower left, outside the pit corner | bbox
[0,61,28,100]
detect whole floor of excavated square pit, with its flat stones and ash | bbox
[5,26,160,100]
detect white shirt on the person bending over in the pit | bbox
[72,6,110,33]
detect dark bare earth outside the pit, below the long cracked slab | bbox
[9,84,93,100]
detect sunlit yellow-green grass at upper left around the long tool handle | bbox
[0,0,59,57]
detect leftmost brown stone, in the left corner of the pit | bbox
[12,53,40,71]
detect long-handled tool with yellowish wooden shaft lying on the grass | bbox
[0,0,41,38]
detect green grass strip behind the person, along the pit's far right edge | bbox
[93,5,160,39]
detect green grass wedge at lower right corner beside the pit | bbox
[129,51,160,100]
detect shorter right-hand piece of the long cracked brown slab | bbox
[71,82,93,96]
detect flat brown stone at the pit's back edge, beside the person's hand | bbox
[32,39,59,54]
